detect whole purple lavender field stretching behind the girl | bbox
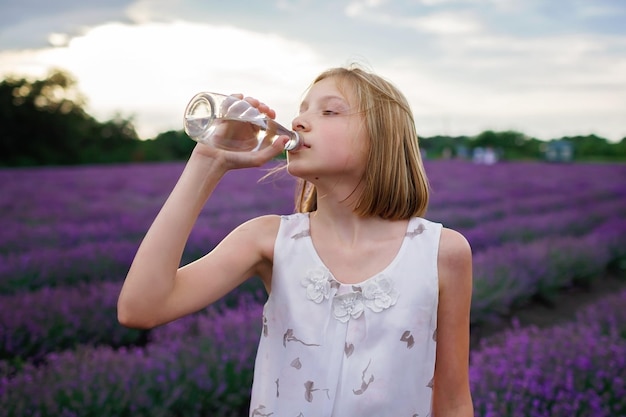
[0,161,626,417]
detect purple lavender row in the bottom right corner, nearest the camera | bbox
[470,291,626,417]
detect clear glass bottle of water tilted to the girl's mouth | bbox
[183,92,301,152]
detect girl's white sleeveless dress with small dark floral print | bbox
[250,213,442,417]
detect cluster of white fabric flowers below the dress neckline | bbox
[301,268,400,323]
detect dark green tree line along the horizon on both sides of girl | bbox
[0,69,626,167]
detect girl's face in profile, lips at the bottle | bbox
[287,78,369,186]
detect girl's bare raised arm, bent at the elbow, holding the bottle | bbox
[118,127,288,328]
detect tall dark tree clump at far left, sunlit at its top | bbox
[0,70,137,166]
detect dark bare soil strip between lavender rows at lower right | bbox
[470,270,626,349]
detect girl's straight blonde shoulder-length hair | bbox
[295,64,429,220]
